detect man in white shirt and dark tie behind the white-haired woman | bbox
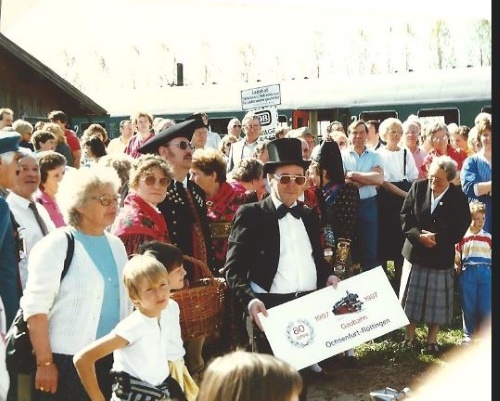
[7,153,56,290]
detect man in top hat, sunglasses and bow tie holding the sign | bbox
[225,138,340,399]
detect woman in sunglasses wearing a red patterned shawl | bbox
[111,155,172,256]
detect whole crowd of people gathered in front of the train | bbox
[0,104,492,401]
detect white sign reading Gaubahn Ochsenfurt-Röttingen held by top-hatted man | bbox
[259,266,409,369]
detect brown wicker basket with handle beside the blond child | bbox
[171,255,227,341]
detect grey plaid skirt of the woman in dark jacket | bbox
[400,259,454,326]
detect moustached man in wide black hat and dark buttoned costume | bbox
[139,119,215,379]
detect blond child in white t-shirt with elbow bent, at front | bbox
[73,255,187,401]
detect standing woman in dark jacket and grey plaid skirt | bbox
[399,156,471,355]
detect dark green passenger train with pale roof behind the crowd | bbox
[71,67,492,138]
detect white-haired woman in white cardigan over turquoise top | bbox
[20,167,132,400]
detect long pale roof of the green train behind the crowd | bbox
[107,67,492,116]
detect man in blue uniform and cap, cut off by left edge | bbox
[0,131,22,327]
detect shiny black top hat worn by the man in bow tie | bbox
[264,138,310,175]
